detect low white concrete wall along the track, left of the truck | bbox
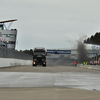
[0,58,32,67]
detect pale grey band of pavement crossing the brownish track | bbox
[0,72,100,91]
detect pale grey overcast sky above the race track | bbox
[0,0,100,50]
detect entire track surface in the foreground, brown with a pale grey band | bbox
[0,66,100,100]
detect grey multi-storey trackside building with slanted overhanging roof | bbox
[0,20,17,50]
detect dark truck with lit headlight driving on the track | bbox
[33,47,46,67]
